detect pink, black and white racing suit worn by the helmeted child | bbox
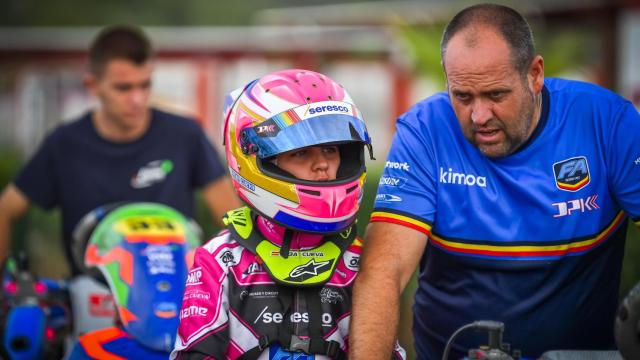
[171,207,405,360]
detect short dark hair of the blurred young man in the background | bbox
[89,25,153,76]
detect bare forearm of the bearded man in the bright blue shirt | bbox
[349,222,427,360]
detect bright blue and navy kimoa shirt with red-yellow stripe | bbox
[372,79,640,359]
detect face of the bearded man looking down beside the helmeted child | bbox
[443,28,543,157]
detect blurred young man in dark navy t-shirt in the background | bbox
[0,26,240,275]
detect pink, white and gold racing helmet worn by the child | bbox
[223,69,372,233]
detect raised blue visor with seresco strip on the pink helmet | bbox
[241,102,371,159]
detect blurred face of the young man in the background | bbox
[87,59,153,130]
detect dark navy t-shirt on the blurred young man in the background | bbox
[15,109,225,274]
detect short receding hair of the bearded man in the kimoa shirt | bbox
[440,4,536,74]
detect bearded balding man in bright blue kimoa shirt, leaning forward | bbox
[350,4,640,360]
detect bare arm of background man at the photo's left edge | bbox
[0,184,31,264]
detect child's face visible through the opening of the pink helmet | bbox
[276,145,340,181]
